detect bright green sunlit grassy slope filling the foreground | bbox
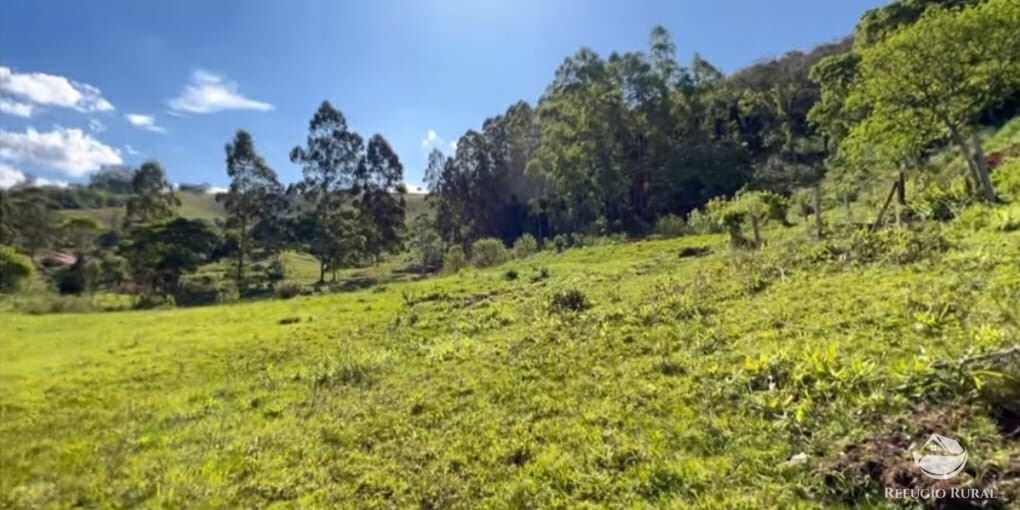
[0,224,1020,508]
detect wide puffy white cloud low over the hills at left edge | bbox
[0,126,123,176]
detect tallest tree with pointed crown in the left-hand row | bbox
[291,101,363,284]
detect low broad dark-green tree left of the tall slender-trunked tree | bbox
[120,217,220,296]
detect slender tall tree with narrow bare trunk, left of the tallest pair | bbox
[217,130,286,289]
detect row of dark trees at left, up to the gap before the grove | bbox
[0,102,406,297]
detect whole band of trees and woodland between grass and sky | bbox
[0,0,1020,302]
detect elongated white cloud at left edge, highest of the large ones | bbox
[0,66,114,111]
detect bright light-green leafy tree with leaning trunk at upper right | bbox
[844,0,1020,202]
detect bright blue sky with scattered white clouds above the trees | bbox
[0,0,885,191]
